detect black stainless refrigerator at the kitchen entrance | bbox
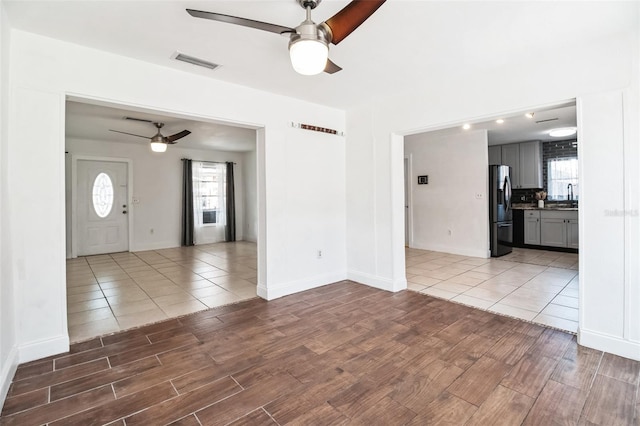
[489,165,513,257]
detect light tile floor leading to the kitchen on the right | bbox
[405,248,578,333]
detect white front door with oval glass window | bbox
[76,160,129,256]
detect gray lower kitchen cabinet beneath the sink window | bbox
[540,210,578,248]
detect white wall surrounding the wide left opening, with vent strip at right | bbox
[3,30,346,370]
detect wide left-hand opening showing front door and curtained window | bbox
[65,99,264,342]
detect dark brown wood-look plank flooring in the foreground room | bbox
[0,281,640,426]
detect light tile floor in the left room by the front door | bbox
[67,241,257,342]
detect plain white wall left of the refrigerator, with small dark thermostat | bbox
[404,130,489,257]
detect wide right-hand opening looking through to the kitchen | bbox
[404,101,579,333]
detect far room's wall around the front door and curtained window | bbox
[66,139,252,251]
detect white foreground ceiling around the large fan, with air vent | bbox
[2,0,637,108]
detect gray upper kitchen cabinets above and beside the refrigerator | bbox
[489,141,542,189]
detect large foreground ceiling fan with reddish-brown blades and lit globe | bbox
[187,0,386,75]
